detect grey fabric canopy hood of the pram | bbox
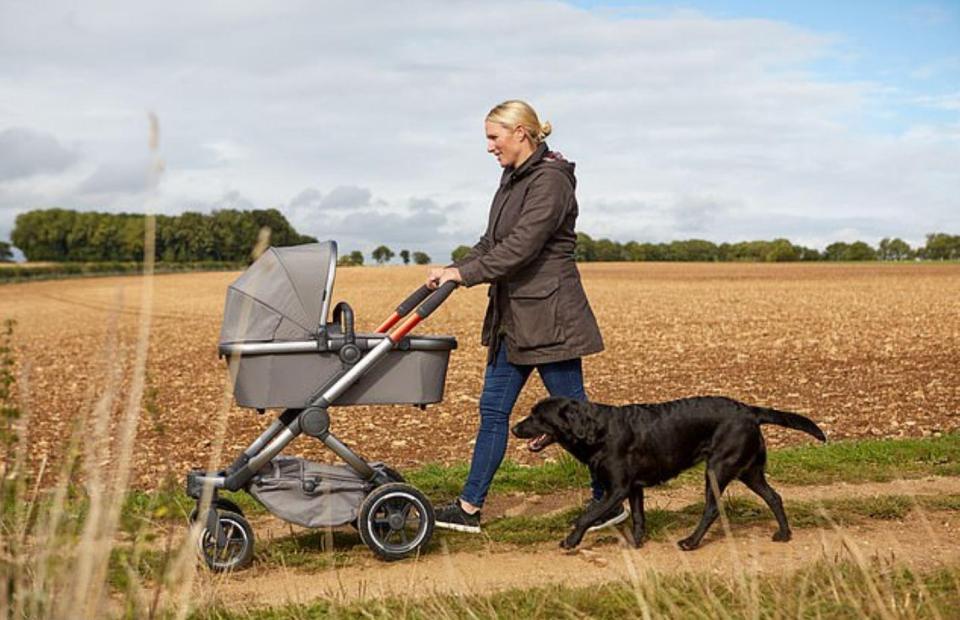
[220,241,337,344]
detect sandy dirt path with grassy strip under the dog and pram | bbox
[199,478,960,607]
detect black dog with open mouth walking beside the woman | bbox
[513,396,827,550]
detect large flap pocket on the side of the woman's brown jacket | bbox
[508,277,566,349]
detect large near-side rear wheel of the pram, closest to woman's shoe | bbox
[357,482,434,560]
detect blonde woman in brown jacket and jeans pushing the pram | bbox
[427,101,627,533]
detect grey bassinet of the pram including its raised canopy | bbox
[219,241,457,409]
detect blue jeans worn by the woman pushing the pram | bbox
[460,343,603,506]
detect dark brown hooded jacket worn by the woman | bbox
[454,143,603,364]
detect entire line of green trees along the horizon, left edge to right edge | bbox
[0,209,960,265]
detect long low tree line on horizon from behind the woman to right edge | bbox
[451,232,960,262]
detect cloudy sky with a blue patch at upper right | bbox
[0,0,960,262]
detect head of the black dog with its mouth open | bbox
[513,397,602,452]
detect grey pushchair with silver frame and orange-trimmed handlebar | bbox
[187,241,457,571]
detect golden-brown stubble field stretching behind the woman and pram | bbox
[0,263,960,488]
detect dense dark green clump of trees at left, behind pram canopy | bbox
[10,209,316,262]
